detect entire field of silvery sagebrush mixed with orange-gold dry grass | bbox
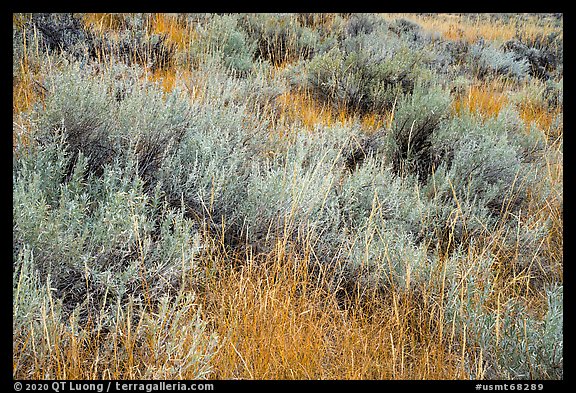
[12,13,563,379]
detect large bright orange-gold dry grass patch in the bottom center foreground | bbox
[204,237,467,379]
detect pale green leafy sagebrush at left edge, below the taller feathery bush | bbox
[13,136,205,321]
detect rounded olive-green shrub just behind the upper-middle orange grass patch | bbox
[305,18,432,112]
